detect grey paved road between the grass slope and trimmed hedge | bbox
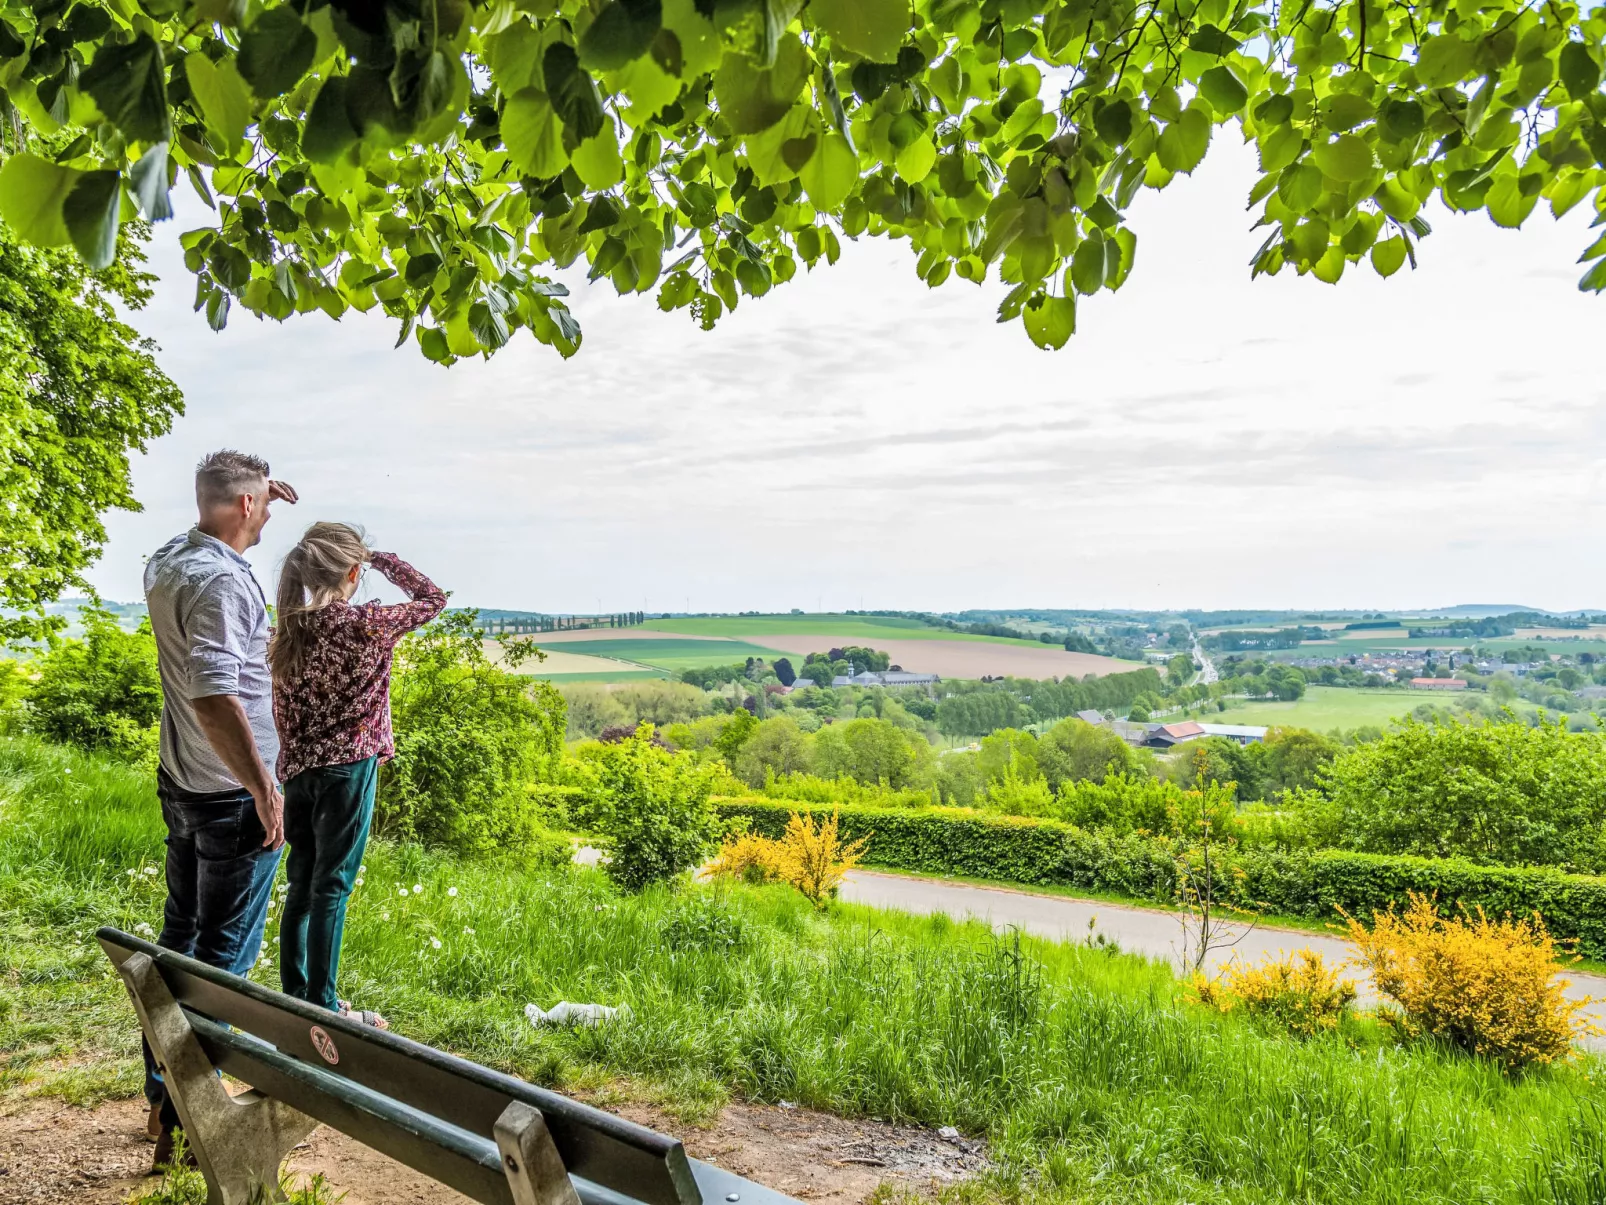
[842,871,1606,1049]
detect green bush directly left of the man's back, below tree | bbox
[26,606,162,762]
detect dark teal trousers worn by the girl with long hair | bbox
[279,757,379,1009]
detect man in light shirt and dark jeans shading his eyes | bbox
[145,450,296,1166]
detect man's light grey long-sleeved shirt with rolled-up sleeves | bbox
[145,527,279,794]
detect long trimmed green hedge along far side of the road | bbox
[715,795,1606,958]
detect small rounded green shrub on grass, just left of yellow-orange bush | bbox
[588,723,719,892]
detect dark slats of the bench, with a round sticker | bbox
[96,927,797,1205]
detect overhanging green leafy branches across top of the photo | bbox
[0,0,1606,362]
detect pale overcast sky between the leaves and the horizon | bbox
[90,132,1606,611]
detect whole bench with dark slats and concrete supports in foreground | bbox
[96,929,798,1205]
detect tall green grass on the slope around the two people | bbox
[0,741,1606,1205]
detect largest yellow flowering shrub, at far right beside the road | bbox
[1344,892,1600,1068]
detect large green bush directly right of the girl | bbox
[374,612,565,853]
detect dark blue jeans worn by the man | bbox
[145,771,279,1126]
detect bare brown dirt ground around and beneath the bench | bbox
[0,1101,986,1205]
